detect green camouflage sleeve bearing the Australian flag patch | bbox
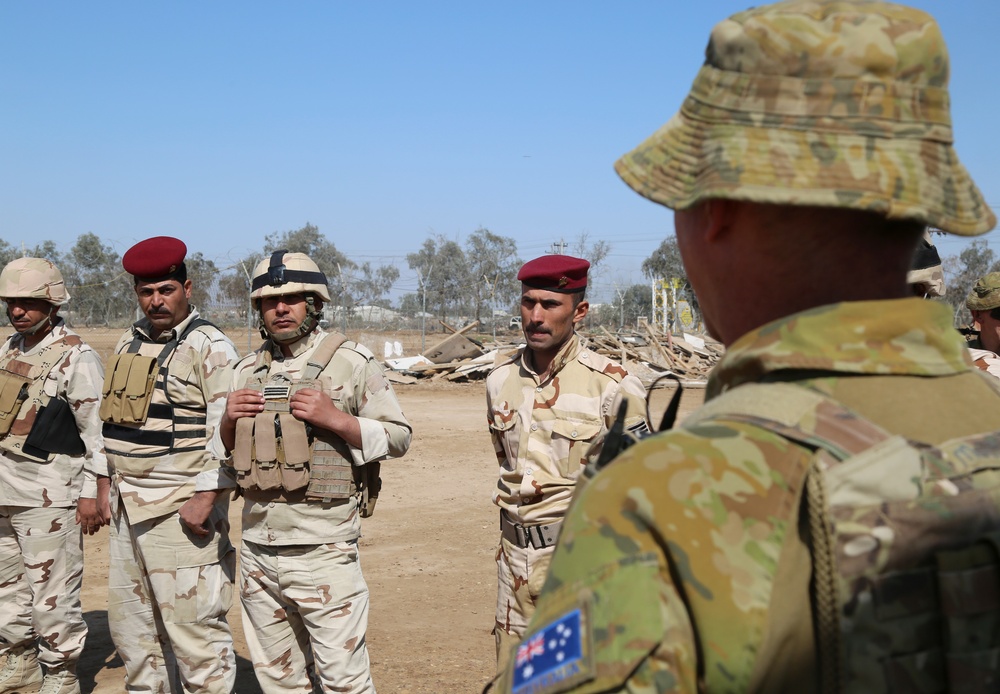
[498,422,809,694]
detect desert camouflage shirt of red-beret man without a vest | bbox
[486,335,646,525]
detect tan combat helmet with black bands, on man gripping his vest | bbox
[250,250,330,342]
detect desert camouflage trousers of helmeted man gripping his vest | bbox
[240,540,375,694]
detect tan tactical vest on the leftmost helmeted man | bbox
[0,335,83,463]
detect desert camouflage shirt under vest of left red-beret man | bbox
[107,308,239,523]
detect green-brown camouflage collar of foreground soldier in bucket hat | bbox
[705,298,972,399]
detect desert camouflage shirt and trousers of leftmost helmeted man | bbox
[0,317,108,671]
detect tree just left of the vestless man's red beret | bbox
[465,227,521,320]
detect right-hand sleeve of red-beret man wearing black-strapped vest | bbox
[195,331,239,492]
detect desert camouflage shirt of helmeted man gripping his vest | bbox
[212,330,412,545]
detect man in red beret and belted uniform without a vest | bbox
[486,255,646,669]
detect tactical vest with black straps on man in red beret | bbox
[100,318,215,474]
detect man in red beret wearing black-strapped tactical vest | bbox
[101,236,238,694]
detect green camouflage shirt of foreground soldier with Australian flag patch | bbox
[498,299,1000,694]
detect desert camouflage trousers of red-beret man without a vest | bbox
[493,538,555,672]
